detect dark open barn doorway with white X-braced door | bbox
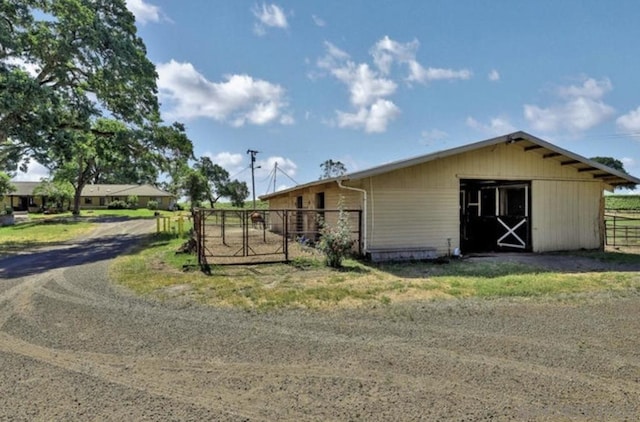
[460,179,531,253]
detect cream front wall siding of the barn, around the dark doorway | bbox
[345,144,603,255]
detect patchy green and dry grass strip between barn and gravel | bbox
[111,235,640,309]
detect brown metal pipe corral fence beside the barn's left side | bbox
[194,208,362,266]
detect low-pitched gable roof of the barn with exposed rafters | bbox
[260,131,640,200]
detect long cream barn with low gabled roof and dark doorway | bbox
[260,132,640,260]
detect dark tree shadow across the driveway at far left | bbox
[0,234,154,279]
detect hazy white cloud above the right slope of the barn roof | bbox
[524,78,615,133]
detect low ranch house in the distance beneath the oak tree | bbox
[4,182,176,212]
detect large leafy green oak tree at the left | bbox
[0,0,192,212]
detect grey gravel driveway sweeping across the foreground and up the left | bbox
[0,220,640,421]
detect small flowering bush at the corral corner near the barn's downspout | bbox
[316,197,354,268]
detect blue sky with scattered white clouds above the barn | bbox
[16,0,640,195]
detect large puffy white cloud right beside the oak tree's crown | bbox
[157,60,293,126]
